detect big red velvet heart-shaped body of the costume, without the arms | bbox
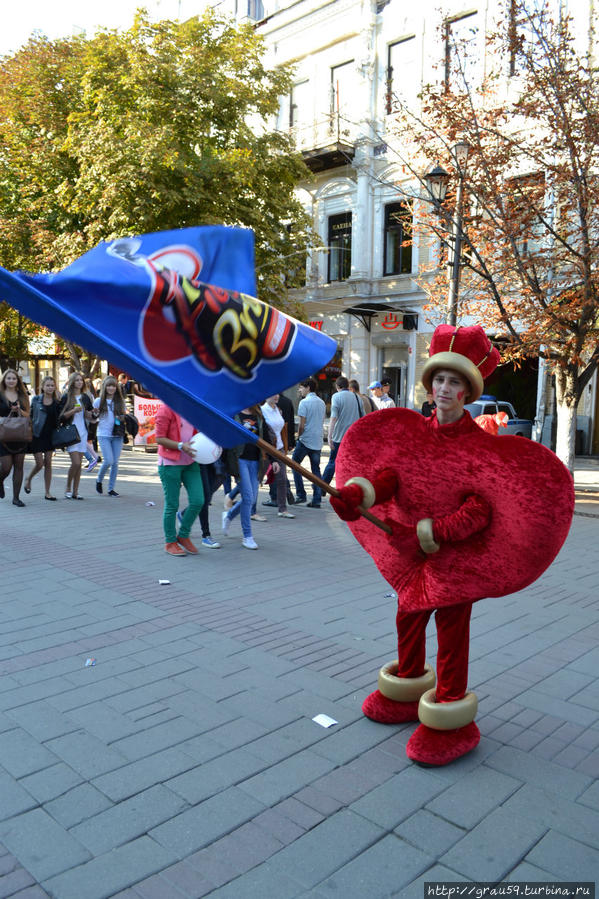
[336,409,574,612]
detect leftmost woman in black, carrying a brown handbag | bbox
[0,368,31,508]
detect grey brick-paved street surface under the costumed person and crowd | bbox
[0,452,599,899]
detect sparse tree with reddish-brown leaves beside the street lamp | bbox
[390,0,599,470]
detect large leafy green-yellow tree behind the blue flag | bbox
[0,12,311,370]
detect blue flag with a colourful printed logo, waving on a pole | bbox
[0,226,336,446]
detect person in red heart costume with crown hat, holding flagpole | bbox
[331,325,574,765]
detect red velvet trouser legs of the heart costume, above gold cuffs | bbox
[396,602,472,702]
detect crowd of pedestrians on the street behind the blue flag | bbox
[0,369,430,557]
